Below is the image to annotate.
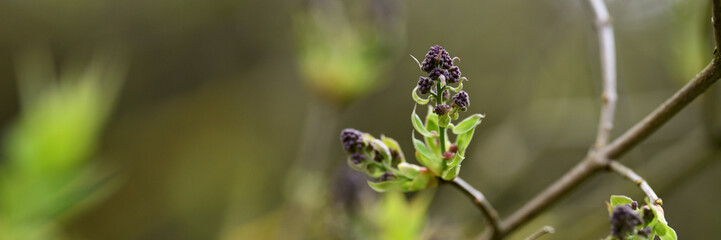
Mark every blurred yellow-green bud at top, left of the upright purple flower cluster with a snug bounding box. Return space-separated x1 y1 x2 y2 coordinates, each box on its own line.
293 0 403 104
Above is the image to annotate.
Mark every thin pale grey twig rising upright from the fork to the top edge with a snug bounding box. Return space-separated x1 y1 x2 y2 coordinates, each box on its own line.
588 0 618 150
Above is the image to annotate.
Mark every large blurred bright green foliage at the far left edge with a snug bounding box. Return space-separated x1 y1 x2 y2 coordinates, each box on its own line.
0 49 124 240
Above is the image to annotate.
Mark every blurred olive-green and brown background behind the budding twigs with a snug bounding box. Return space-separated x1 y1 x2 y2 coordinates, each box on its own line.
0 0 721 240
